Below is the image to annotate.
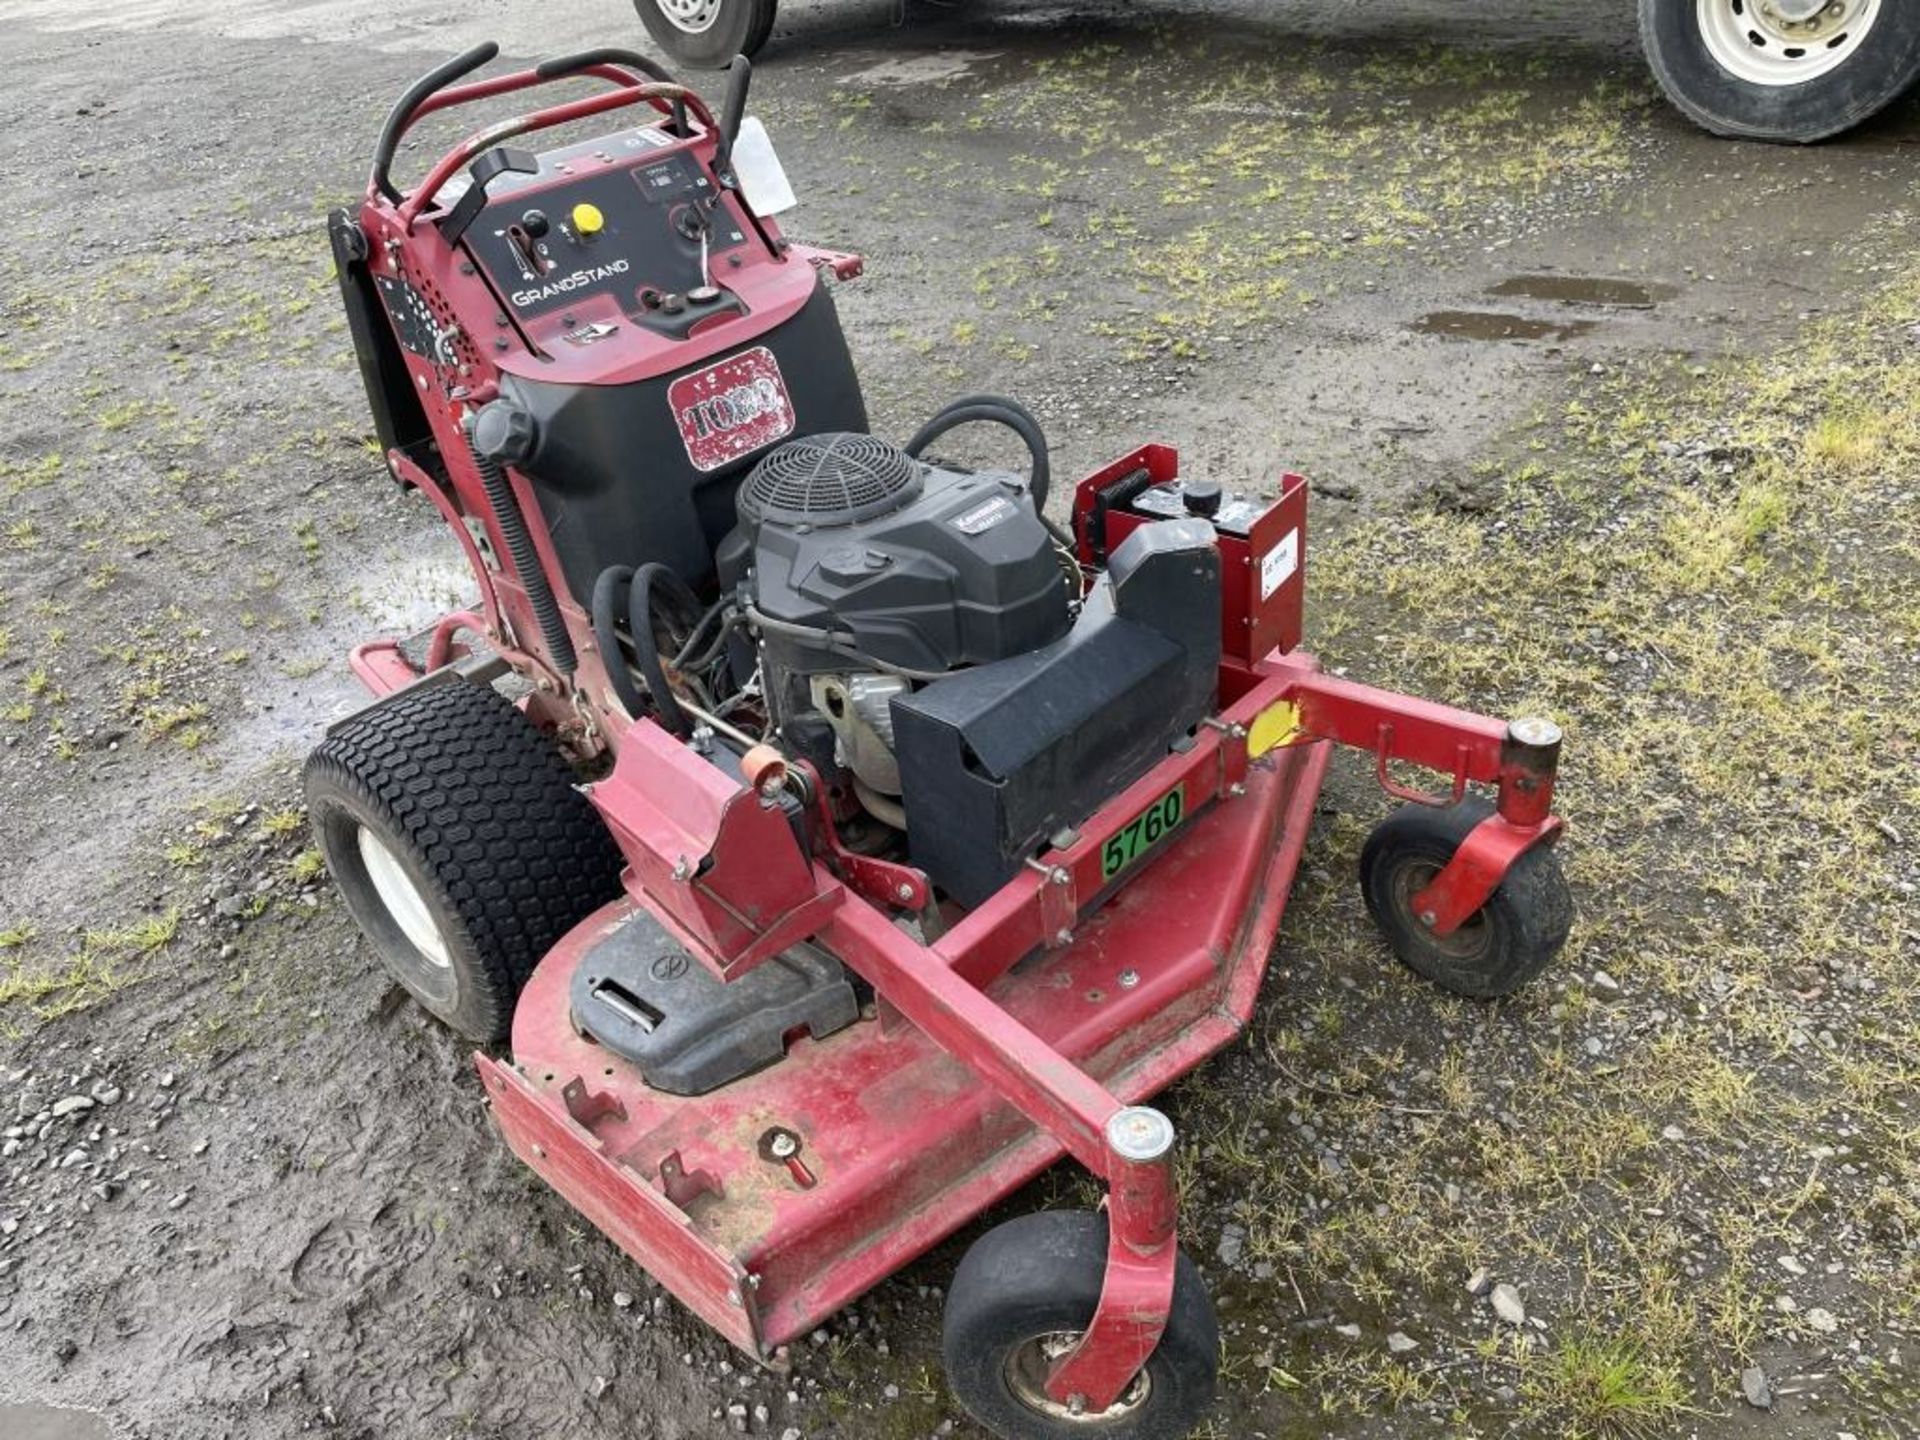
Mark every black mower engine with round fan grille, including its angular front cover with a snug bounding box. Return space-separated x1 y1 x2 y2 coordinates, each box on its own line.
716 434 1219 904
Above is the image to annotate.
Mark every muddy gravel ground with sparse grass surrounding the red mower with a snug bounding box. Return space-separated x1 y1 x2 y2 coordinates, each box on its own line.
0 0 1920 1440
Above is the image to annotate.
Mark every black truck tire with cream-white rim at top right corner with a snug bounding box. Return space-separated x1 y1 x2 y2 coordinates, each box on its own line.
1640 0 1920 144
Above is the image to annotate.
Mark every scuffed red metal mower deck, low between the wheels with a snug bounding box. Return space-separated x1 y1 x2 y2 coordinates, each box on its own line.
476 745 1331 1357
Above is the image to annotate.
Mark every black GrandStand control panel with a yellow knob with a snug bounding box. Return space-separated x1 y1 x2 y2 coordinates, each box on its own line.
442 125 747 332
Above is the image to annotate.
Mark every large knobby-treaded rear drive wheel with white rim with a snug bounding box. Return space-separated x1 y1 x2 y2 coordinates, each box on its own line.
305 680 622 1043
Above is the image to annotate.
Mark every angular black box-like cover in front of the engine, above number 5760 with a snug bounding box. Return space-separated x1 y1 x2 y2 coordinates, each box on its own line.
893 520 1219 906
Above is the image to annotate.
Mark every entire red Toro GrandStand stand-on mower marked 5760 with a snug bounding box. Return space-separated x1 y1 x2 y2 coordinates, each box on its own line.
307 46 1571 1436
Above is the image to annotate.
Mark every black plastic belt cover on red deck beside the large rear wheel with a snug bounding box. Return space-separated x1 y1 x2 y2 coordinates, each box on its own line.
570 910 860 1094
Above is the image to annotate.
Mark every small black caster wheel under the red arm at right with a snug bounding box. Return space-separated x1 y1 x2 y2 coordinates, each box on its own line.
1359 799 1572 1000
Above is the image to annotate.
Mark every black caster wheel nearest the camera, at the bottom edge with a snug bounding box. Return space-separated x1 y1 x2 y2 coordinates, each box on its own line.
941 1210 1219 1440
